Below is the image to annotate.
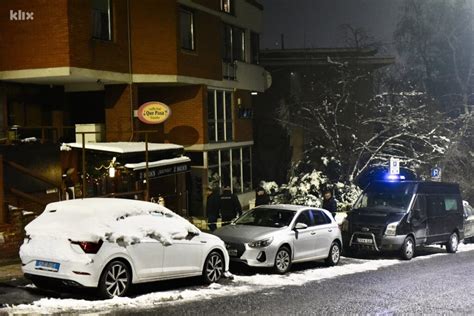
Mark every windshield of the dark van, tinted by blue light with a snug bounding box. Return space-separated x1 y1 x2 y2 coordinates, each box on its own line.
354 182 415 212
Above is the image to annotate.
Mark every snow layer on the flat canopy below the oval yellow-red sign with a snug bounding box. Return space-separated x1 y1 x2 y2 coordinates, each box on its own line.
66 142 183 154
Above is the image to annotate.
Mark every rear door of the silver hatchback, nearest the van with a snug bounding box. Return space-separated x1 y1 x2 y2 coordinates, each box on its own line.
311 210 338 257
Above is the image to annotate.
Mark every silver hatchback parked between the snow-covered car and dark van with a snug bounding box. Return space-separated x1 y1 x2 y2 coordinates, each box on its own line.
214 205 342 274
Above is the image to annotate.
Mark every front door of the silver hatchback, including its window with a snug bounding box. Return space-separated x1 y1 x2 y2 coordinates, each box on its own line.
293 210 317 261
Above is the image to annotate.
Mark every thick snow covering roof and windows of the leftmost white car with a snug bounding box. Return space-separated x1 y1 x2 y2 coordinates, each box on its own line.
25 198 200 245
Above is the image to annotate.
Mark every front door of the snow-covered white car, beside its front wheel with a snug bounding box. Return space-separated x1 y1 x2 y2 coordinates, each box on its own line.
163 235 205 277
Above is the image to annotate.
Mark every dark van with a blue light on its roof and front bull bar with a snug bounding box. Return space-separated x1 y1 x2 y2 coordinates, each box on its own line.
342 181 464 260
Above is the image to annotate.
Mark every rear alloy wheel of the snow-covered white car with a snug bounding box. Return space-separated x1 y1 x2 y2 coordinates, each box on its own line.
99 261 130 298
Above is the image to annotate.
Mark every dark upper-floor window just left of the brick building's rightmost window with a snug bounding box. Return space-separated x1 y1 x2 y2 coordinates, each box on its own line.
222 24 245 63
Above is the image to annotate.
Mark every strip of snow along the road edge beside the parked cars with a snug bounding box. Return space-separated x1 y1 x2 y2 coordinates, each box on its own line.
5 244 474 314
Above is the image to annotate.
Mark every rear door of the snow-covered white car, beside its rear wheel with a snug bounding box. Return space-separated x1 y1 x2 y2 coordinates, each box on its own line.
127 237 164 280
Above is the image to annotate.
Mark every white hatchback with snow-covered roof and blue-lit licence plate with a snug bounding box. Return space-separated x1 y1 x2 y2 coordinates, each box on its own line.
20 198 229 298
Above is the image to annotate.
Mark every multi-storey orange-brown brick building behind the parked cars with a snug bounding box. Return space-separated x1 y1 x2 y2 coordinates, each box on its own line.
0 0 271 223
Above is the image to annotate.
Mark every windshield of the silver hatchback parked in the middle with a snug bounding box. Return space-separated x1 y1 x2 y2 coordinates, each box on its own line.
235 208 296 227
